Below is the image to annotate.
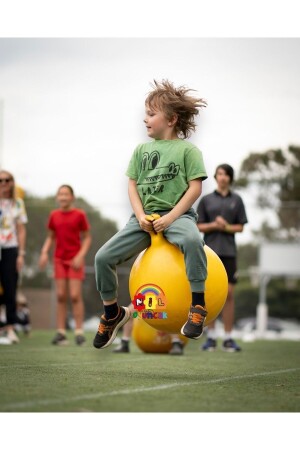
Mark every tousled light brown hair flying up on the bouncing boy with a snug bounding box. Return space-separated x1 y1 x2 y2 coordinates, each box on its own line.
145 80 207 138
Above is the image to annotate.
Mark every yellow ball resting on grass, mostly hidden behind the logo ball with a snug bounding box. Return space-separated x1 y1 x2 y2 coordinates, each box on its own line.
132 318 188 353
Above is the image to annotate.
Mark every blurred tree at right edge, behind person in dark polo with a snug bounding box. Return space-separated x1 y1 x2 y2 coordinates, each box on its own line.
235 145 300 241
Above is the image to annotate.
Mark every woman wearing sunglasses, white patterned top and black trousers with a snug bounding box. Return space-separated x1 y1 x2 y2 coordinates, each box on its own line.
0 170 28 344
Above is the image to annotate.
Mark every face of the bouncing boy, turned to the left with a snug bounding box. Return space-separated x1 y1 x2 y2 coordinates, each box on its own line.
144 105 174 139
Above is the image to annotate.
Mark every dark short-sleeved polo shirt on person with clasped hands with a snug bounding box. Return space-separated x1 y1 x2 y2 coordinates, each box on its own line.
197 191 248 257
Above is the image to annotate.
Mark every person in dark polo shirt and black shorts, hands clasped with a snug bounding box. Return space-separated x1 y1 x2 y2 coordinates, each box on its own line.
197 164 248 352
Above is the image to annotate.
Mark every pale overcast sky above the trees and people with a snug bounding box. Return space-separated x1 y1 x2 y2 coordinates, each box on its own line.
0 37 300 242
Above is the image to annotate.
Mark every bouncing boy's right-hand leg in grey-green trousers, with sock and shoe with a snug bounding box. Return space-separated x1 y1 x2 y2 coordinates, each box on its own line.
164 214 207 339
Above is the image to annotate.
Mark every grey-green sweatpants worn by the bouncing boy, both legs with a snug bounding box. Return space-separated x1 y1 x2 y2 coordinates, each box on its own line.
95 208 207 300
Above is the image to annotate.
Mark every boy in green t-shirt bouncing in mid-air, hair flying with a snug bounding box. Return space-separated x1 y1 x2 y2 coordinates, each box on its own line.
94 80 207 348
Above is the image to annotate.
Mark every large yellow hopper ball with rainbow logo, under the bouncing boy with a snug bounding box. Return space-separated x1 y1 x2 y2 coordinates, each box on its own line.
129 219 228 333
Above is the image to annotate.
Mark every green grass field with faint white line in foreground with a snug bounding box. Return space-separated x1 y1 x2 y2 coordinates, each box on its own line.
0 330 300 412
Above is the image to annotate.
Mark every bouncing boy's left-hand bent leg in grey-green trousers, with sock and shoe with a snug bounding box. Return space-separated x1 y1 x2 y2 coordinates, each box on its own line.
94 216 151 348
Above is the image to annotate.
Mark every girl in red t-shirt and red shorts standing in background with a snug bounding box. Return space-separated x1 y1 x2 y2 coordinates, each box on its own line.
39 185 91 345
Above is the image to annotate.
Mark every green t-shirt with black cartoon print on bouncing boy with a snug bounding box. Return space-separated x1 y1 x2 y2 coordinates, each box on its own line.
126 139 207 211
